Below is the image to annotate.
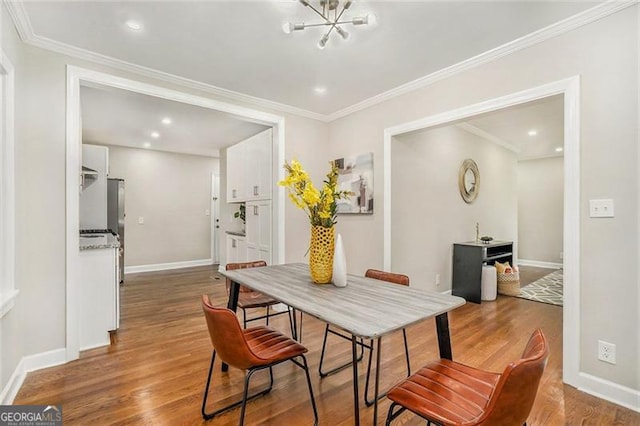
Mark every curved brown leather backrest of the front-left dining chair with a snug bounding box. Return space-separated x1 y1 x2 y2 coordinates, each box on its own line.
202 295 264 370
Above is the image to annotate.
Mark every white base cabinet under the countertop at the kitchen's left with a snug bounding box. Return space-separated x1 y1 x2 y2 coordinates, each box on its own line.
78 247 120 350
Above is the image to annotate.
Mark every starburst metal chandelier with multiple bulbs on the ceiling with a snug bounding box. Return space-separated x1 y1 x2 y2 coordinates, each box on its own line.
282 0 375 49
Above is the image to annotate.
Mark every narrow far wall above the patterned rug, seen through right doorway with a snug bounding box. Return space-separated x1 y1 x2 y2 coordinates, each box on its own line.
518 156 564 263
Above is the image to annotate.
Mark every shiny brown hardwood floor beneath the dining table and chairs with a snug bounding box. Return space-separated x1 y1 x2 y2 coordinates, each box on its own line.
14 267 640 425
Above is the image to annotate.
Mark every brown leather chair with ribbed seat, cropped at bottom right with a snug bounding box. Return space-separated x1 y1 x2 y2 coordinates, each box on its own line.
386 329 549 426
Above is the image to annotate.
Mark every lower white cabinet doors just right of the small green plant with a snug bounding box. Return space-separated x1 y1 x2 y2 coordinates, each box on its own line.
246 200 271 264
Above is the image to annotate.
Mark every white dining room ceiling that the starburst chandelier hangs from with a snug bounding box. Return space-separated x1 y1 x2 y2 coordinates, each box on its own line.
21 0 599 116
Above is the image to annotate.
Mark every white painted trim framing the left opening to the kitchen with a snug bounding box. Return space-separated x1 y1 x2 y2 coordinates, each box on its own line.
66 65 285 361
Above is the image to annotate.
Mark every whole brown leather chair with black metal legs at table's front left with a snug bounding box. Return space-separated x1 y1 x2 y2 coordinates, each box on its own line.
202 295 318 425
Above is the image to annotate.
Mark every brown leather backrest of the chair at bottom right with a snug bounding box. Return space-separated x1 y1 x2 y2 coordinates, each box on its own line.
478 329 549 425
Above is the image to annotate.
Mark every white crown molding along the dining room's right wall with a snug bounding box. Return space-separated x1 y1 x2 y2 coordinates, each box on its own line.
327 0 638 122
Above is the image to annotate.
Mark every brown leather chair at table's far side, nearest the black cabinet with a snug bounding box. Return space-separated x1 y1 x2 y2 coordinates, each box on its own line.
318 269 411 406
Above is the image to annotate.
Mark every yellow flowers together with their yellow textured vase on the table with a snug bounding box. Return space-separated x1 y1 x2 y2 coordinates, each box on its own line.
278 160 353 284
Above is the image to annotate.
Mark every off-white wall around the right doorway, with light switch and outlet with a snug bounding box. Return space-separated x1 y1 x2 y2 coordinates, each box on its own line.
328 5 640 390
